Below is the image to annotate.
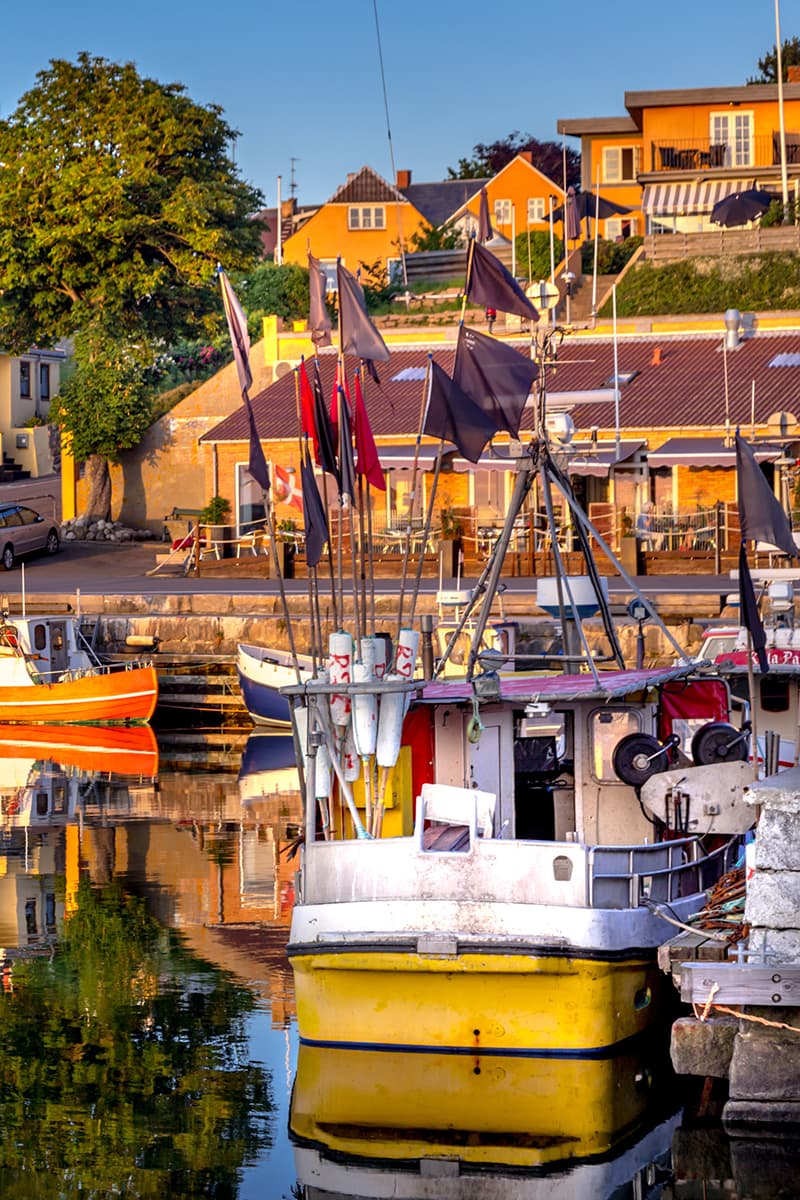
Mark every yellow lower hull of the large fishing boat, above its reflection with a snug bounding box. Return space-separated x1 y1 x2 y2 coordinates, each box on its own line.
290 944 670 1057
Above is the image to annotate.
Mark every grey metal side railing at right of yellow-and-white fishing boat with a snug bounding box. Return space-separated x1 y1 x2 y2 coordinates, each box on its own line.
588 838 740 908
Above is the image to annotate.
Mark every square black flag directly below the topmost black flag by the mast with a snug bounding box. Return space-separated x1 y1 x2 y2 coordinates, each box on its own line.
453 325 539 438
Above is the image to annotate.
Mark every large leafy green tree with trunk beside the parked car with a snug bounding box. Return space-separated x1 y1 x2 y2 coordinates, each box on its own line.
0 53 263 516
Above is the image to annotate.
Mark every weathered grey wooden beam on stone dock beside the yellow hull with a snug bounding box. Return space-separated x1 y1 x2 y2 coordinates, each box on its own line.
680 962 800 1007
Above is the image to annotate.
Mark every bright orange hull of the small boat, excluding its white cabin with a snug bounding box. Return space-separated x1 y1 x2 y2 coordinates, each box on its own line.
0 665 158 725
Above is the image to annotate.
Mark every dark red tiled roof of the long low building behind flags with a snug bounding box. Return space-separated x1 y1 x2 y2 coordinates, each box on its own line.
203 331 800 449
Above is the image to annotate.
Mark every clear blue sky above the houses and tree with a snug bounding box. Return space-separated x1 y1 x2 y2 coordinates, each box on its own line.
0 0 786 204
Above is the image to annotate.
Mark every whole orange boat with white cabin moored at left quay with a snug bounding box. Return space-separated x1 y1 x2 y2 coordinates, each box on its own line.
0 614 158 725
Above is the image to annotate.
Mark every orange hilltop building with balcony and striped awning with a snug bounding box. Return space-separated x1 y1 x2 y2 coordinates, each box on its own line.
557 68 800 238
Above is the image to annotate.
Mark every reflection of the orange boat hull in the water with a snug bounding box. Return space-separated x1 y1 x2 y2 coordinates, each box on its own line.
0 725 158 778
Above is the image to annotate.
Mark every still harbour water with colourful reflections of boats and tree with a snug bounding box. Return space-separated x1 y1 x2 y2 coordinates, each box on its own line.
0 730 796 1200
